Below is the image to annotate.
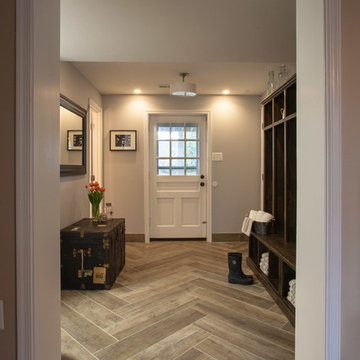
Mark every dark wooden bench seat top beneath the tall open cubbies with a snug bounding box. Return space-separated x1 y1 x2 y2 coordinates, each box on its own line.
251 233 296 271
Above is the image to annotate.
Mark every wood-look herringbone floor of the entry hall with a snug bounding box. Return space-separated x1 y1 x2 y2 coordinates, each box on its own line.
61 241 295 360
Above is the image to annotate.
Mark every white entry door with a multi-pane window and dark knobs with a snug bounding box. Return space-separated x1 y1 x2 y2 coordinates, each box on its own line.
149 115 207 238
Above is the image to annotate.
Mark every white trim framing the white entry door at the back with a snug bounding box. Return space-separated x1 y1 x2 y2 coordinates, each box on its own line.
144 110 212 243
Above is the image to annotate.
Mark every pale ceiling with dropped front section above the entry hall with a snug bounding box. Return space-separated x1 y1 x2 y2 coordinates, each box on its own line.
61 0 296 94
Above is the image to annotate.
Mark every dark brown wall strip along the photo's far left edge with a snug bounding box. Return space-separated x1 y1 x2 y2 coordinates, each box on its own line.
0 0 16 360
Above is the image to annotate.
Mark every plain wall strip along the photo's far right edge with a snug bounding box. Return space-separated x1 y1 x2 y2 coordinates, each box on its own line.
341 0 360 360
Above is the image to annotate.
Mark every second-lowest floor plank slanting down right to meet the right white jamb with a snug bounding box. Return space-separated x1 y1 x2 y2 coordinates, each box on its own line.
194 301 295 351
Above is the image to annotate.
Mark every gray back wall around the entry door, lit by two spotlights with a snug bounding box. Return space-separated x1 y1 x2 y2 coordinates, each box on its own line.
103 95 260 234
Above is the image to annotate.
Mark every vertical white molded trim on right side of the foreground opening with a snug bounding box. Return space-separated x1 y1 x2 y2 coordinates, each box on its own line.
325 0 342 360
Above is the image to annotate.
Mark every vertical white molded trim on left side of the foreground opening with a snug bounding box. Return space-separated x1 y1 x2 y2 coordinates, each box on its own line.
15 0 35 360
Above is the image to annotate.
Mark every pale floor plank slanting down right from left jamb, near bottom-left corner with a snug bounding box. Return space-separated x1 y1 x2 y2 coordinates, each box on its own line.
61 304 117 353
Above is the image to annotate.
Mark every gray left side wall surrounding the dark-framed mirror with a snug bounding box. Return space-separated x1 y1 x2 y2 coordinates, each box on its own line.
60 62 102 228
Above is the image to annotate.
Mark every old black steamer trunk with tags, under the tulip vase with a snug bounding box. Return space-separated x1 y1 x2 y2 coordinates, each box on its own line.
60 219 125 290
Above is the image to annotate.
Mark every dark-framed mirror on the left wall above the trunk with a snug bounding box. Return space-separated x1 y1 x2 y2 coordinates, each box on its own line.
60 94 86 176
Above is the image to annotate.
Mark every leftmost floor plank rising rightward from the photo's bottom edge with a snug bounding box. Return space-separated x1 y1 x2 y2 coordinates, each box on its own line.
95 309 204 360
